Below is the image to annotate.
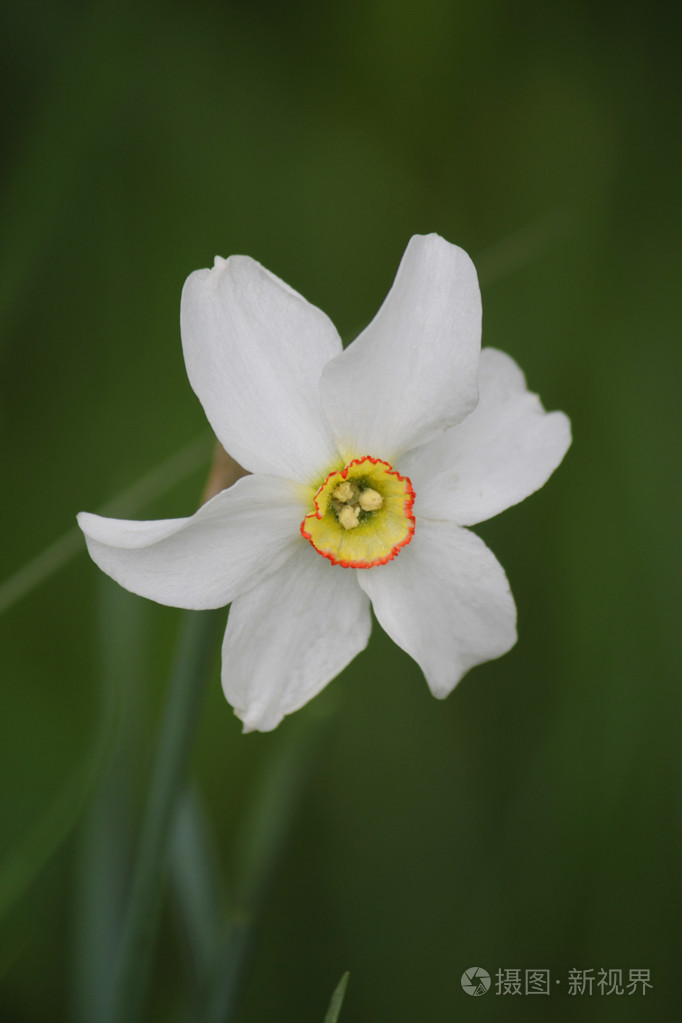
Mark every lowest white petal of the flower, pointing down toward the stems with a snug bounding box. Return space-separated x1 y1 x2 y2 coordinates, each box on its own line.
223 544 371 731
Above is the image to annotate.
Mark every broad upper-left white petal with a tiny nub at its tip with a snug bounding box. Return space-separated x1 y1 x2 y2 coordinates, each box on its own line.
180 256 342 484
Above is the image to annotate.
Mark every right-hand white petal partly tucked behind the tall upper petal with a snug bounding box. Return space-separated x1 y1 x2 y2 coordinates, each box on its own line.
399 348 571 526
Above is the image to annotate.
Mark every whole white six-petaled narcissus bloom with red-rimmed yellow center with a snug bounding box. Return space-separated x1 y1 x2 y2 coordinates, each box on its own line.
79 234 571 731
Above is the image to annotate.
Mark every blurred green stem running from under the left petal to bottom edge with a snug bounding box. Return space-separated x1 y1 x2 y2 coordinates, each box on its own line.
108 611 224 1023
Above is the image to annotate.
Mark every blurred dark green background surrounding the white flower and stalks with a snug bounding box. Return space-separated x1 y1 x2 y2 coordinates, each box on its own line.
0 0 682 1023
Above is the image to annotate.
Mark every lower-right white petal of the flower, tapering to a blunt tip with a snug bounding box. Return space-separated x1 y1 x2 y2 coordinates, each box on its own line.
358 519 516 699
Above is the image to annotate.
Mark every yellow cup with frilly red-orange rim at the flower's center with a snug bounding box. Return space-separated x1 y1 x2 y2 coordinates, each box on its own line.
301 455 414 569
